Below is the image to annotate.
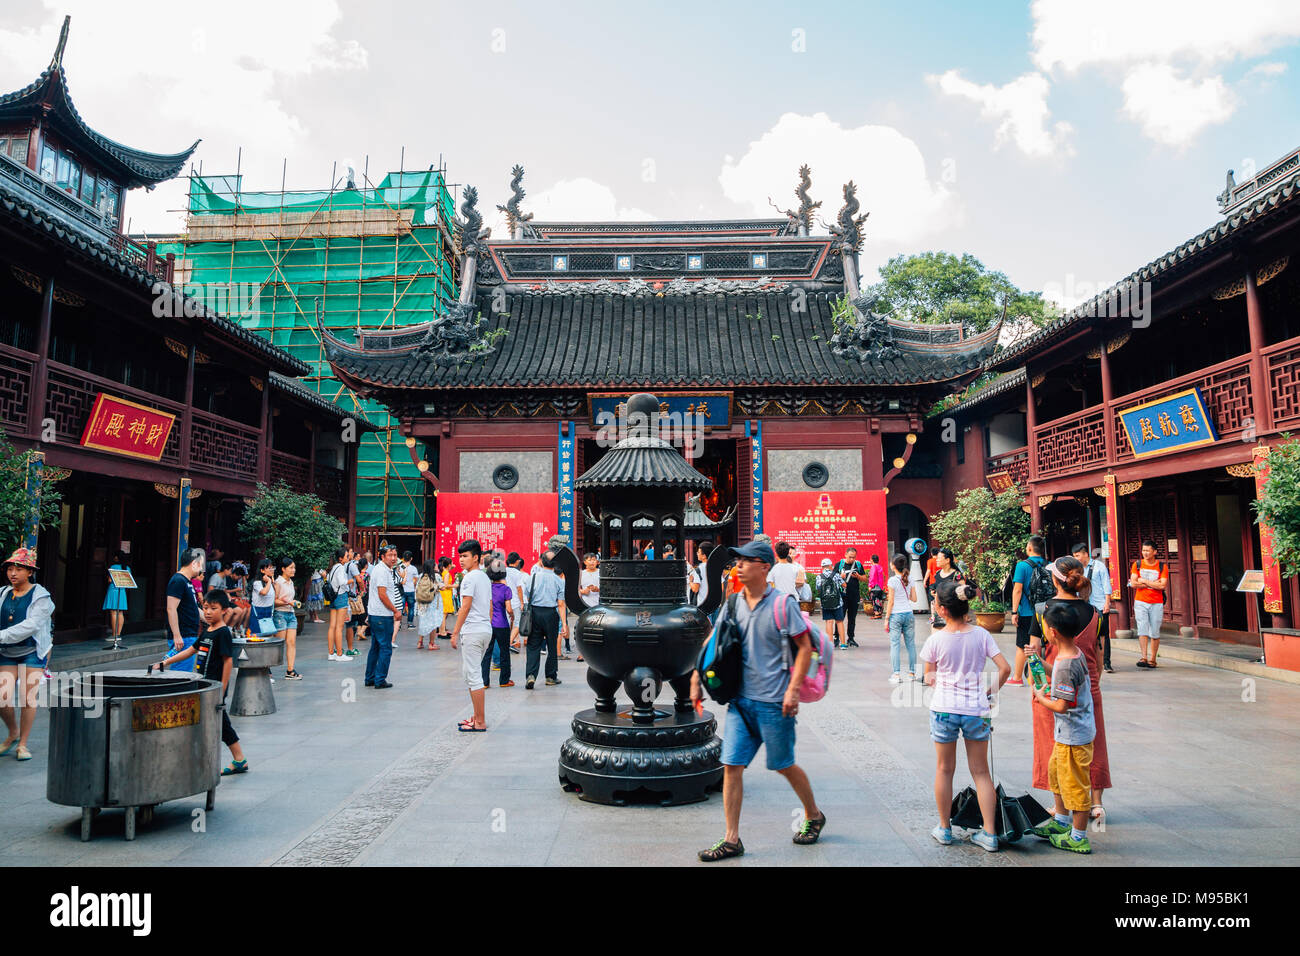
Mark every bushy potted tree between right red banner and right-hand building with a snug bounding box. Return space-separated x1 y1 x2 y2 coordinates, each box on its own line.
930 485 1030 611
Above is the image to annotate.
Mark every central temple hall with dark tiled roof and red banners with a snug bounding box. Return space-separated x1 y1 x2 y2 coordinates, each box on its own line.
321 168 998 558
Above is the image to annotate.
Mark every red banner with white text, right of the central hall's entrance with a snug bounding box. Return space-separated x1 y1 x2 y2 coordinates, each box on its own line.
763 490 889 571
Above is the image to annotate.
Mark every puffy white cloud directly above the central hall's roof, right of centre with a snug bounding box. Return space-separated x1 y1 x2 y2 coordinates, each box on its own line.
718 113 961 274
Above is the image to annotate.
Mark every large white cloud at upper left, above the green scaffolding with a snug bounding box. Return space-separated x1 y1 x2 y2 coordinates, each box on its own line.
0 0 368 232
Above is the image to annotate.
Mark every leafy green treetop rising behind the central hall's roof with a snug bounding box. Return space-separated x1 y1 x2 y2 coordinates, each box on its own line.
871 252 1061 332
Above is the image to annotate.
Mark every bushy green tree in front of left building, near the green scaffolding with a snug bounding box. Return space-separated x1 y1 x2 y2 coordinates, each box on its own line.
239 481 345 593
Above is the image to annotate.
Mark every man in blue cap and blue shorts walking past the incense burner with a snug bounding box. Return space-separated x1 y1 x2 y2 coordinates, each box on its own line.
690 541 826 862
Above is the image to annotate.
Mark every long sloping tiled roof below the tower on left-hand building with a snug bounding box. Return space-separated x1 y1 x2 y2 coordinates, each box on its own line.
0 179 312 375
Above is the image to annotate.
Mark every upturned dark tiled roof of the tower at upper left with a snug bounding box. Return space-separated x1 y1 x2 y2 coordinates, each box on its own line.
0 65 200 189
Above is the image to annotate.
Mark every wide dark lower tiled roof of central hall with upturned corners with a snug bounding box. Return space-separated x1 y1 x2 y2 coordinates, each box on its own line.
322 293 992 389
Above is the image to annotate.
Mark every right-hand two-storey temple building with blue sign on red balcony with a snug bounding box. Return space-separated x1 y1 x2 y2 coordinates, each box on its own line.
930 151 1300 669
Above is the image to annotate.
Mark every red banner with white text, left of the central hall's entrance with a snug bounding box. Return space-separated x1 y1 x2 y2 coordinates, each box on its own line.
437 492 560 568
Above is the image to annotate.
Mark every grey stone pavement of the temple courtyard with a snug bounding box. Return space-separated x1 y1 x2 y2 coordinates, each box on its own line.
0 618 1300 866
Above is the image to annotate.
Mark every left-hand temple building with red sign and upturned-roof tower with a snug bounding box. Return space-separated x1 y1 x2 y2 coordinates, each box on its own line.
0 21 373 640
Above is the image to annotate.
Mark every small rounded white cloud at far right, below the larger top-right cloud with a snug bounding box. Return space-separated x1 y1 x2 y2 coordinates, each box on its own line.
1123 64 1236 147
